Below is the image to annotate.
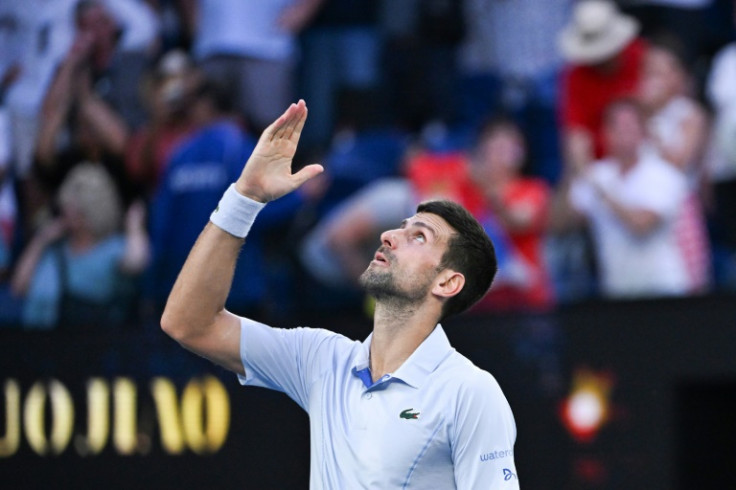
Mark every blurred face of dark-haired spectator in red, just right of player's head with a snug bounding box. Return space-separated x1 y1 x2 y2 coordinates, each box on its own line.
476 126 526 179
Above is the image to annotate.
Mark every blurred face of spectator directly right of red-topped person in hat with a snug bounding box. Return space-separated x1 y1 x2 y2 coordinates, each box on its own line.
639 46 685 108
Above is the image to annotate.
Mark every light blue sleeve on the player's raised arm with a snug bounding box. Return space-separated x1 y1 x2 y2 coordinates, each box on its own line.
238 318 344 410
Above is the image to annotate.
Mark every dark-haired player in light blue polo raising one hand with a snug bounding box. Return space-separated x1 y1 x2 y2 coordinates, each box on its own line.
161 100 519 489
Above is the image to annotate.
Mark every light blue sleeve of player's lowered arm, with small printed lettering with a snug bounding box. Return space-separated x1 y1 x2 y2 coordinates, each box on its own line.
452 371 519 490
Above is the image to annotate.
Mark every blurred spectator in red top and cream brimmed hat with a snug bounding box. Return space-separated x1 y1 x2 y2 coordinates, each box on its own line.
558 0 645 174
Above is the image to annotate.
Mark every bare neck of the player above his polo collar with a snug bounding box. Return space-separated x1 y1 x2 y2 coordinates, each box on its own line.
370 301 439 381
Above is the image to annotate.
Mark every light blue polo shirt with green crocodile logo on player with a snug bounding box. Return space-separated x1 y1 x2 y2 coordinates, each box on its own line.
240 319 519 490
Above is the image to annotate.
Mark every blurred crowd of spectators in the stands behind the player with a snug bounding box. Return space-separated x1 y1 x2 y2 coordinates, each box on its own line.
0 0 736 329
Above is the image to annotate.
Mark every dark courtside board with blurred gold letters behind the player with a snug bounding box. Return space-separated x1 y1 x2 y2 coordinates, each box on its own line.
0 298 736 490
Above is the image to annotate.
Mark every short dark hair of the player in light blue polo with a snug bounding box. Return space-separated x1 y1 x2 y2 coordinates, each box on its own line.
417 200 498 320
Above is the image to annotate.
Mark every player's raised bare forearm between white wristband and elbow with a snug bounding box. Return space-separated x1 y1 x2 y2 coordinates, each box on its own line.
161 223 243 341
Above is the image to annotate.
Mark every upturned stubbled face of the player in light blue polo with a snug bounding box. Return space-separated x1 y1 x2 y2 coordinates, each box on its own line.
360 213 454 303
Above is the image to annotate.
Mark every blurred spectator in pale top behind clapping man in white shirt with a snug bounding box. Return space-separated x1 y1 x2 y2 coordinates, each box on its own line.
639 37 711 292
